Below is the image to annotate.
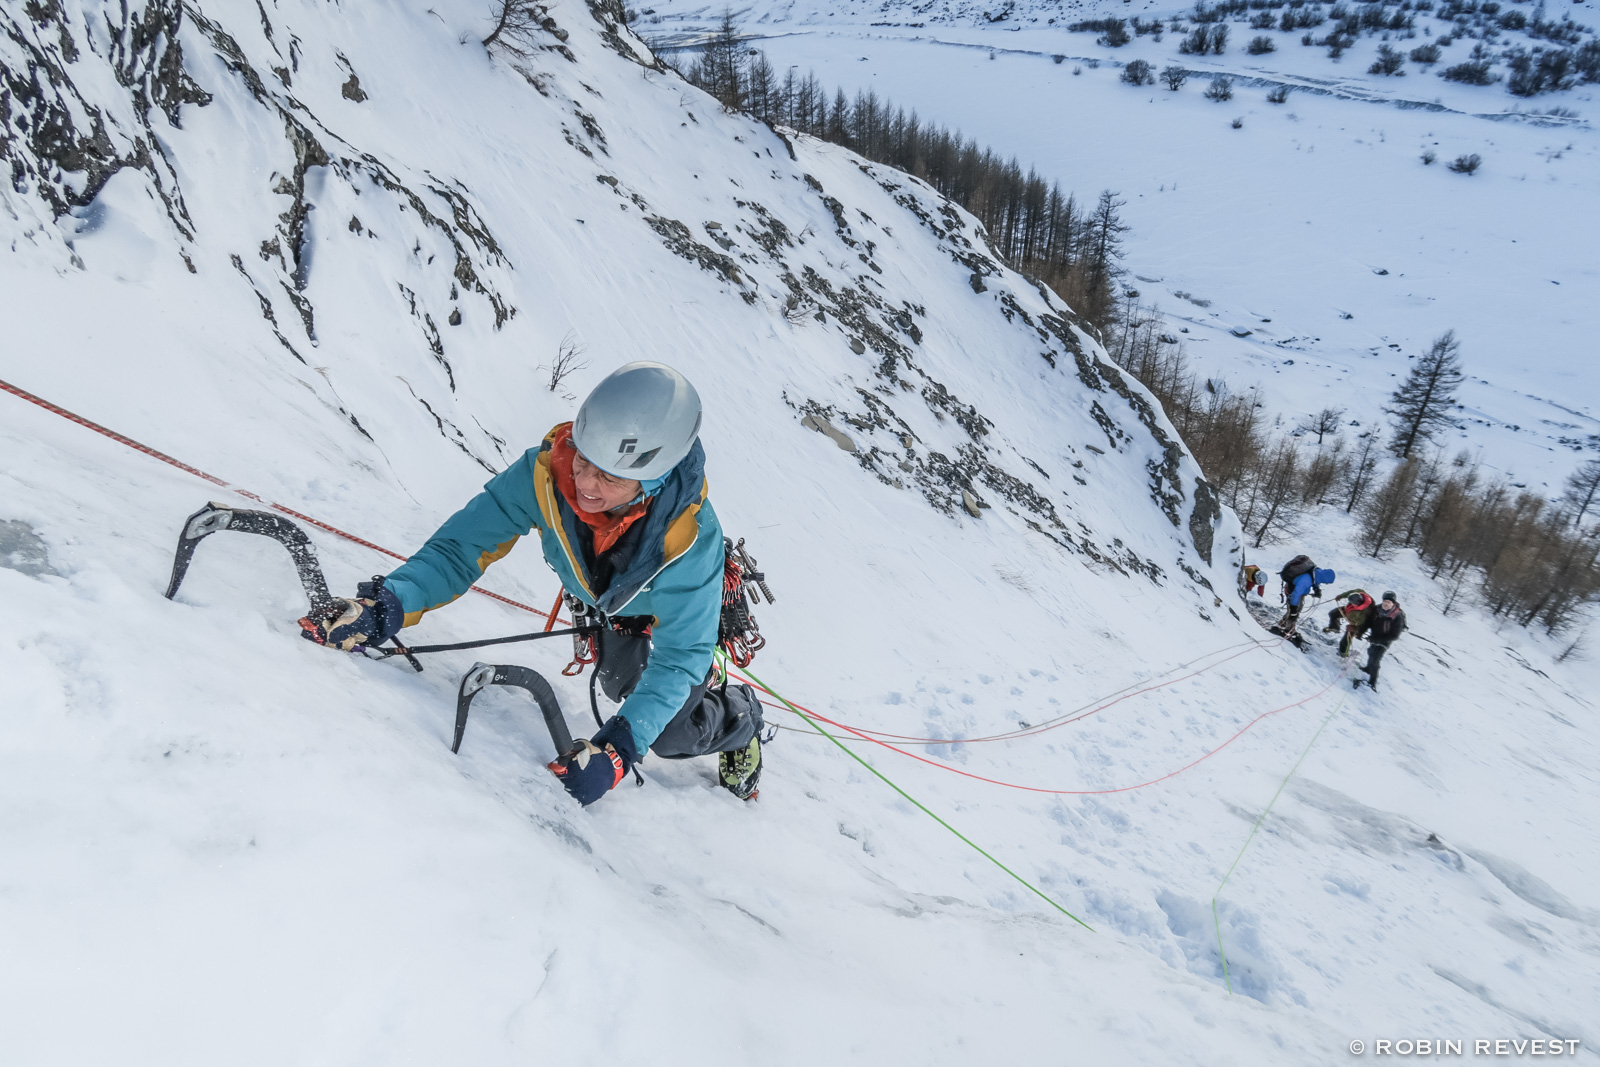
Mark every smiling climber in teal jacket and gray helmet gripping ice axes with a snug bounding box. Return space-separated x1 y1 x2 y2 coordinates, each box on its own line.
306 363 762 805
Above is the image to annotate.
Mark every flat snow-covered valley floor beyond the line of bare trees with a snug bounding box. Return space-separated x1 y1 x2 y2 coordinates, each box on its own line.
638 2 1600 496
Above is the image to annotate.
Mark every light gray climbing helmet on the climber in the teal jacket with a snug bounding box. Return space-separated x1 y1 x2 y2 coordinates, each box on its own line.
573 362 701 482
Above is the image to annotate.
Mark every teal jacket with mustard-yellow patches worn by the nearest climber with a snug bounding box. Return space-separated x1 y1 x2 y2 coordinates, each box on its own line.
386 424 723 753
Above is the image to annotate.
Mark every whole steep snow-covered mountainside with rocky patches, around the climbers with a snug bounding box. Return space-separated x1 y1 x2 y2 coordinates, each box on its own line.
0 0 1600 1064
